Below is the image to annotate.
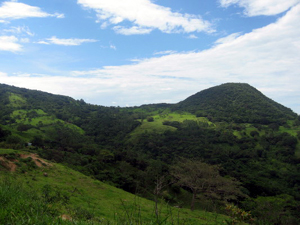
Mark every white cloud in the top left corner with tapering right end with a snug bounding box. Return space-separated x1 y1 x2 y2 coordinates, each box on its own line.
0 1 64 21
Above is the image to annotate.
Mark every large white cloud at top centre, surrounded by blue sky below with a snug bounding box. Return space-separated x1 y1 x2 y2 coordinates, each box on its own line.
77 0 213 35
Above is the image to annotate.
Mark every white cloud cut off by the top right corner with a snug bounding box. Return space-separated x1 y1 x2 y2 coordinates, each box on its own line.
220 0 300 16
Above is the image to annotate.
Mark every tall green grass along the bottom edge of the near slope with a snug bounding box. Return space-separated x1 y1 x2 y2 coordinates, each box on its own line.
0 174 225 225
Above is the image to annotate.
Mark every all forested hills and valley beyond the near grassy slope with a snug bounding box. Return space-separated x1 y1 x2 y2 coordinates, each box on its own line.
0 83 300 224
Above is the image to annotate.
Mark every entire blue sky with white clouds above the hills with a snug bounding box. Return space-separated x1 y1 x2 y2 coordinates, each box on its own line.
0 0 300 114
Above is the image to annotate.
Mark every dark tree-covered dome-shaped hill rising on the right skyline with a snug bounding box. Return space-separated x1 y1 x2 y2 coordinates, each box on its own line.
174 83 296 124
